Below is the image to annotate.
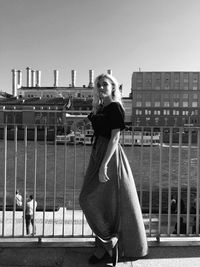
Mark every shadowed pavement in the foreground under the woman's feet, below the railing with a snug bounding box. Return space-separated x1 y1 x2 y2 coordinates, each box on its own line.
0 244 200 267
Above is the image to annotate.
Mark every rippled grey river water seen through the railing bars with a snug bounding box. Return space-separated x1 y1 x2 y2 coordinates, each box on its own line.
0 140 197 213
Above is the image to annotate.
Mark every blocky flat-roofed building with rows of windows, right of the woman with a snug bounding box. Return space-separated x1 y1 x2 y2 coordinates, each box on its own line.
131 71 200 127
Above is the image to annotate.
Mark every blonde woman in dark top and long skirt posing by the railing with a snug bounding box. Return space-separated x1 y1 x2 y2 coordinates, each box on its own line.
79 74 148 266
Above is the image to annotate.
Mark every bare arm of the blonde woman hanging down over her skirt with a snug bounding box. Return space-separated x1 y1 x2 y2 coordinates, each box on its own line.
99 129 120 183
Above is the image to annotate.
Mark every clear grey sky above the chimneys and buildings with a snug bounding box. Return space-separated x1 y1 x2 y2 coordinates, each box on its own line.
0 0 200 96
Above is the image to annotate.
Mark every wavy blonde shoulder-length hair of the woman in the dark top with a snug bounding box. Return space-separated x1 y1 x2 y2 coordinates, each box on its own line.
92 73 124 114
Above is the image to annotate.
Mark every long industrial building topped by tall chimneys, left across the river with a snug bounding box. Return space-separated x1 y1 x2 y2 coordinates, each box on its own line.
0 67 132 139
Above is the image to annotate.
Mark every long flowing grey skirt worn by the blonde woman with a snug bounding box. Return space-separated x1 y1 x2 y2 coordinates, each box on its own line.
79 136 148 257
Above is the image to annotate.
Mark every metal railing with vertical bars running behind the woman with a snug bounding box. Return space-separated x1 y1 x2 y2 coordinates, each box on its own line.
0 111 200 242
